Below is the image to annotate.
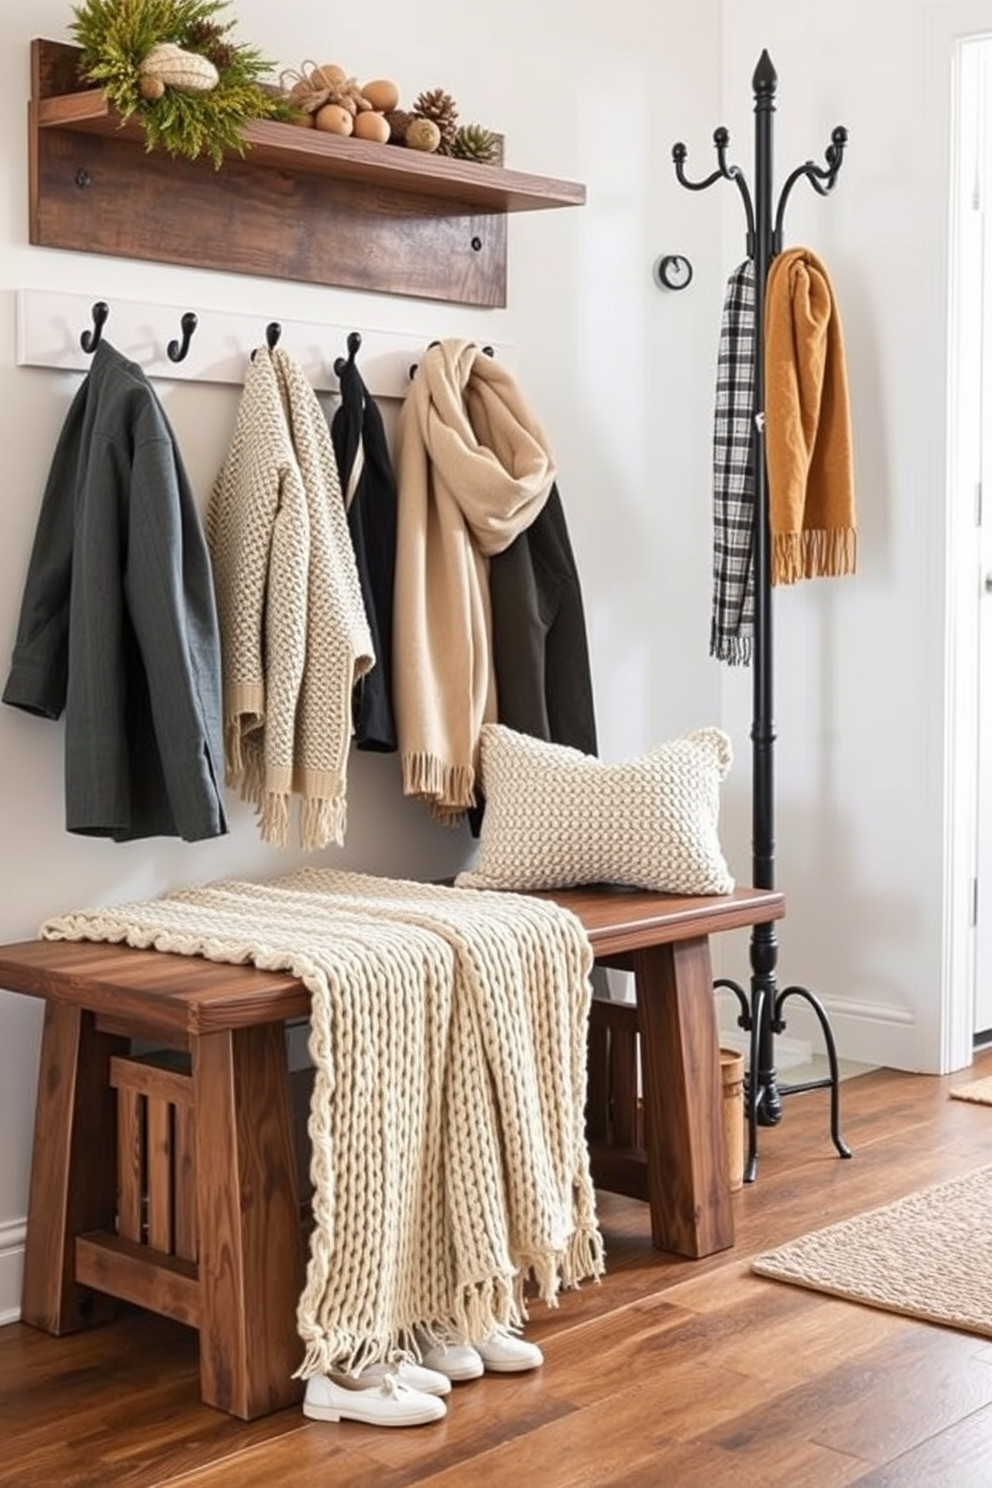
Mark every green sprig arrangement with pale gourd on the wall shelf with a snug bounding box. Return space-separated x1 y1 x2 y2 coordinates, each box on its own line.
70 0 290 168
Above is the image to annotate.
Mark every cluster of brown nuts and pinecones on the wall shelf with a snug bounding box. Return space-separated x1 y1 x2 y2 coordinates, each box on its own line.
281 62 501 162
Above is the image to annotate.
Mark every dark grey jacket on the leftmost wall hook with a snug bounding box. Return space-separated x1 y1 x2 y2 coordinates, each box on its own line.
3 341 228 842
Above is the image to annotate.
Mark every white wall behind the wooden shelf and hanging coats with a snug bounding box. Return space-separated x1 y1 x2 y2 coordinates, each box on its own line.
0 0 728 1318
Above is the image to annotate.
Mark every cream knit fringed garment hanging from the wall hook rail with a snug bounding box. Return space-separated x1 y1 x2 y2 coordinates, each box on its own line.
207 347 375 850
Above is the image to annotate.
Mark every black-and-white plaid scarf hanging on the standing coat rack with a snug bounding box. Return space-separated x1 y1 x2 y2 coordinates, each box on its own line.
709 259 754 667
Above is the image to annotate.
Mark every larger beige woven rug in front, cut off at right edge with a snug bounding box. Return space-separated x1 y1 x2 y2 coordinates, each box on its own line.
751 1167 992 1336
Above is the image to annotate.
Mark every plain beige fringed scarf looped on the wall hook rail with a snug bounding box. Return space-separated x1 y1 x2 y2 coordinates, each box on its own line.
393 341 556 824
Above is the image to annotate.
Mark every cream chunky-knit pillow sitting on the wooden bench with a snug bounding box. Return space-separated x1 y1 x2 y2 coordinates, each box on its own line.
455 723 733 894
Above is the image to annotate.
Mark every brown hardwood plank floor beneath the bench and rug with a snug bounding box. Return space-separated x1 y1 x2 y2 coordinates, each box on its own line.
0 1054 992 1488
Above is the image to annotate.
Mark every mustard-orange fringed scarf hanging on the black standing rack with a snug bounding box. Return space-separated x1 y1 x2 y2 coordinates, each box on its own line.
764 248 857 583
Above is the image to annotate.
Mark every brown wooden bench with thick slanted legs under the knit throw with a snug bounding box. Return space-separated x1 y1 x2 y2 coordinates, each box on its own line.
0 888 784 1420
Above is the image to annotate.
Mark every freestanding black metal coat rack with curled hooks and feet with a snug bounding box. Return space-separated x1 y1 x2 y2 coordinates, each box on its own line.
672 51 851 1183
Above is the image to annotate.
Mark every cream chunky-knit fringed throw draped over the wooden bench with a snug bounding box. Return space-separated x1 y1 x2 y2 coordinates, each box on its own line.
42 869 602 1376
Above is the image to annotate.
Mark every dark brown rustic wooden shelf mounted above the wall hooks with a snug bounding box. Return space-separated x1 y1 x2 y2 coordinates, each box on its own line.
28 40 586 307
